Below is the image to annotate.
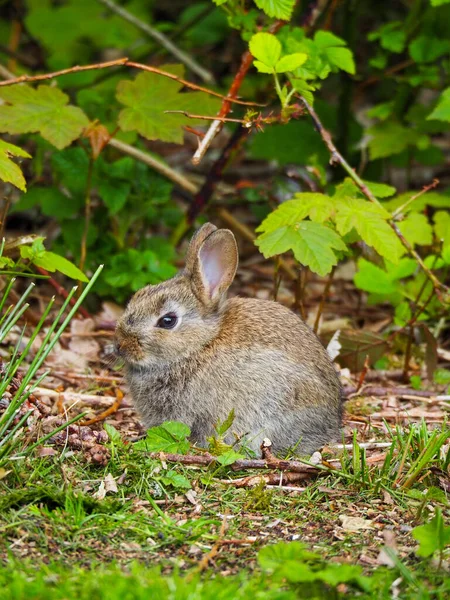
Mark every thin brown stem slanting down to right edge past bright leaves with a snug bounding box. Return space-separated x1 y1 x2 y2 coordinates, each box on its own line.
300 96 449 297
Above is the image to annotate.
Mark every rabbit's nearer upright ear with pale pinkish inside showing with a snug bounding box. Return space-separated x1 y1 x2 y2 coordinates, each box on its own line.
192 229 238 304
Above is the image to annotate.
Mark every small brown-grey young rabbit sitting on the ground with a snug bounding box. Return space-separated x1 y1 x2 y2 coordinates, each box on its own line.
115 223 343 455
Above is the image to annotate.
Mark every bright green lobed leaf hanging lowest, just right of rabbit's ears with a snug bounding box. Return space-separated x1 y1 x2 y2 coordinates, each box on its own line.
255 221 347 276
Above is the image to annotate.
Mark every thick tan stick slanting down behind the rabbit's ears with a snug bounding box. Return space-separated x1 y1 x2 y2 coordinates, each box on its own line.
109 139 297 280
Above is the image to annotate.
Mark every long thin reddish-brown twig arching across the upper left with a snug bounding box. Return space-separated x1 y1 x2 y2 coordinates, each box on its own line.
0 58 263 106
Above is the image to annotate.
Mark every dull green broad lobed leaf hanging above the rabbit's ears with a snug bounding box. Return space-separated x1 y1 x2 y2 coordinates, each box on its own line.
116 65 221 144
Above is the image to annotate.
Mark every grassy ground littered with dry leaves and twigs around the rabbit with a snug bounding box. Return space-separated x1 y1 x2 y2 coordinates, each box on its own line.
0 265 450 598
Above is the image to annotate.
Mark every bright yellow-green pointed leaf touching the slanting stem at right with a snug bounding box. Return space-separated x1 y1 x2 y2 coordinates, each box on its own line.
336 198 405 263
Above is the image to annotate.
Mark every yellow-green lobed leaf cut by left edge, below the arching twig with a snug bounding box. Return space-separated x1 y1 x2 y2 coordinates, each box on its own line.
0 85 89 150
